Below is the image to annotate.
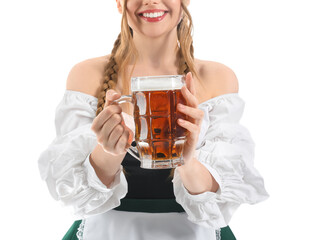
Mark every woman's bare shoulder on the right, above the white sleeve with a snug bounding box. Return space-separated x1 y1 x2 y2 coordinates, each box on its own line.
195 59 239 97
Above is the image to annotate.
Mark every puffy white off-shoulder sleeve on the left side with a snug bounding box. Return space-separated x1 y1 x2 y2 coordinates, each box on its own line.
38 90 127 218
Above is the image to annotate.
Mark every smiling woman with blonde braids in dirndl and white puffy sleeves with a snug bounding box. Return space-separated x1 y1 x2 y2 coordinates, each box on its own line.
39 0 268 240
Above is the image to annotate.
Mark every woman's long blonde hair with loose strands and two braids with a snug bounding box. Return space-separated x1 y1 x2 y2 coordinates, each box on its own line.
96 0 203 178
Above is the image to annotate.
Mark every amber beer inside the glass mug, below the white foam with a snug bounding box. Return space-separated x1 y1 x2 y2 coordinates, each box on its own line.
133 85 187 167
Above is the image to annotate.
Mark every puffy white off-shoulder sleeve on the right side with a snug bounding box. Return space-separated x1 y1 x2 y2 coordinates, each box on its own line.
173 93 269 229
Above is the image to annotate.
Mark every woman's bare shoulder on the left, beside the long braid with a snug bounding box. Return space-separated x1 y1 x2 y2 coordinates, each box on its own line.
66 55 109 97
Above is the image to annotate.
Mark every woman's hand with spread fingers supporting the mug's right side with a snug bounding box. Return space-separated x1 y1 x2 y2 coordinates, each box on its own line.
177 72 204 165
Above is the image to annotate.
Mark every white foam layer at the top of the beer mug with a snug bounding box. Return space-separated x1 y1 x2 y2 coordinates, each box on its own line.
131 75 185 92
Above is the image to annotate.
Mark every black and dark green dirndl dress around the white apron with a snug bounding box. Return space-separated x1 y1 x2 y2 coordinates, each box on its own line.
63 153 236 240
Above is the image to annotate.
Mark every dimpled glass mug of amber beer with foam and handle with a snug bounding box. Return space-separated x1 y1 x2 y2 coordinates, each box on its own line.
115 75 187 169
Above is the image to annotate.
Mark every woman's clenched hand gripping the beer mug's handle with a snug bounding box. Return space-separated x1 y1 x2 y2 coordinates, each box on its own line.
91 89 133 156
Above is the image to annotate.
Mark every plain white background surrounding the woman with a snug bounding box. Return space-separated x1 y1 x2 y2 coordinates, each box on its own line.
0 0 311 240
